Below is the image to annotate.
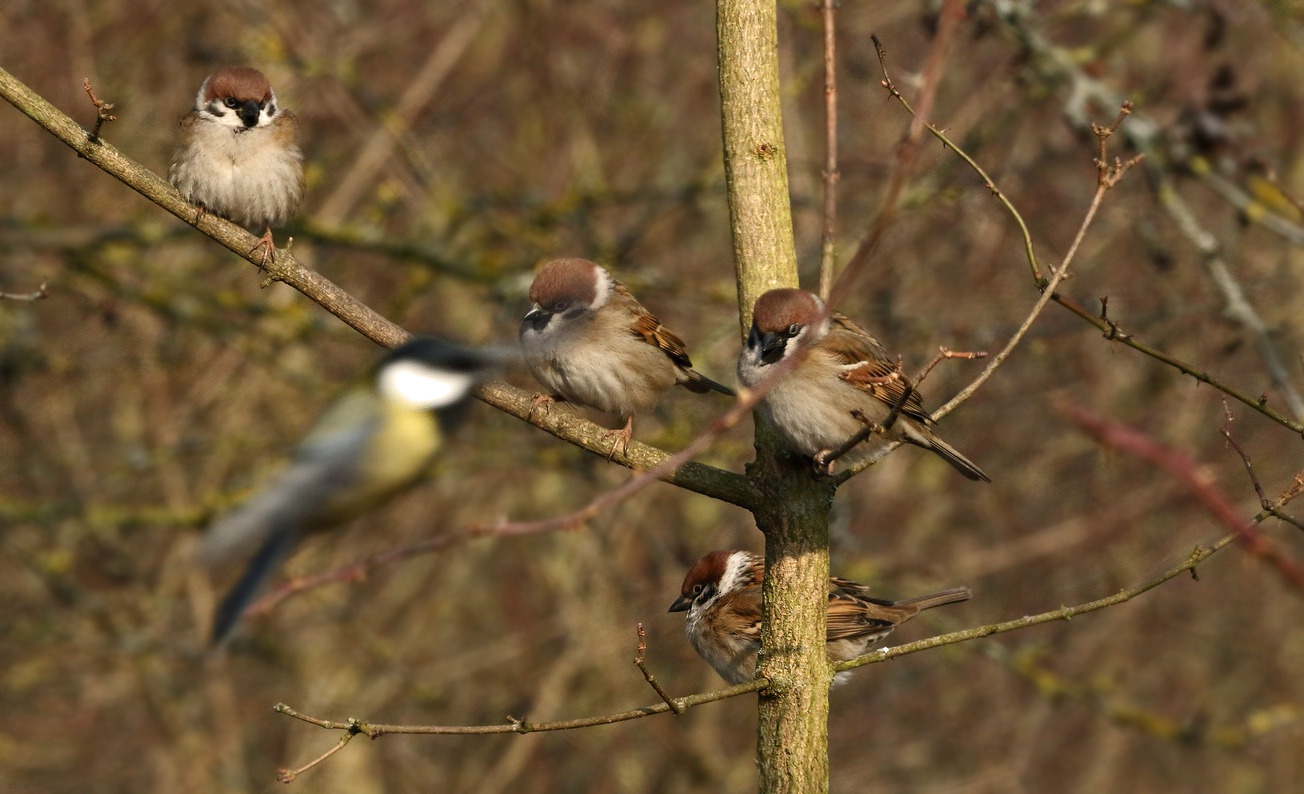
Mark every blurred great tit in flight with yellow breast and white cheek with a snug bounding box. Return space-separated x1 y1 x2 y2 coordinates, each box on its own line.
198 338 494 644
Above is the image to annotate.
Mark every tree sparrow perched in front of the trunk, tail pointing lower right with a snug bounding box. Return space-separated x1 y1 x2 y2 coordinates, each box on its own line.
738 289 991 482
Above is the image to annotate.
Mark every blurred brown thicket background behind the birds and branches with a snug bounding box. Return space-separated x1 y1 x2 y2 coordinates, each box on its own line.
0 0 1304 794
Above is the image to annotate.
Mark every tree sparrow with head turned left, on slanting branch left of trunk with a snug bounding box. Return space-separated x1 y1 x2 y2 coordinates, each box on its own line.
520 259 734 455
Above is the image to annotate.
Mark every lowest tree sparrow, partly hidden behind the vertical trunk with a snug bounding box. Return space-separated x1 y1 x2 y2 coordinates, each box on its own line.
670 551 971 683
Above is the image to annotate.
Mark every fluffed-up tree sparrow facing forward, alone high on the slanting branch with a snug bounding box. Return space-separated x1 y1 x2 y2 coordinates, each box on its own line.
168 66 304 265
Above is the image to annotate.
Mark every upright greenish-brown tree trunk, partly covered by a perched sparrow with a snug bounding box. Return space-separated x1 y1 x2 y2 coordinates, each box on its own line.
716 0 833 794
